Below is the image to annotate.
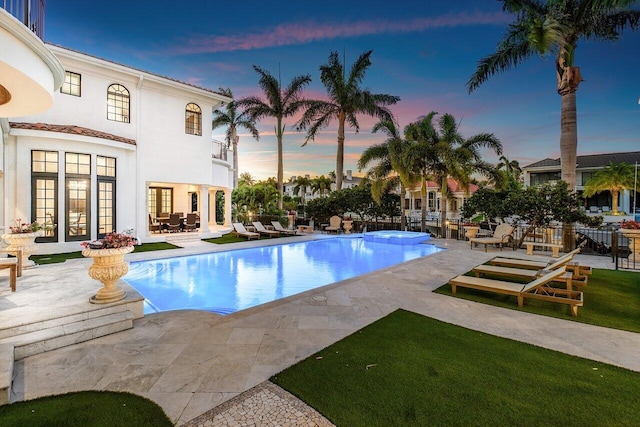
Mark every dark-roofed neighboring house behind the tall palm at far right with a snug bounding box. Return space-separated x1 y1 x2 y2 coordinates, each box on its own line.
522 151 640 214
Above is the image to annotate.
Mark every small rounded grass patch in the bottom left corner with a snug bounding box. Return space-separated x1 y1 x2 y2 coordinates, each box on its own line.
0 391 173 427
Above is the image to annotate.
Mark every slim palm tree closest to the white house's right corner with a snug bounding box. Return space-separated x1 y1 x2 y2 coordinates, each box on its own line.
212 88 260 188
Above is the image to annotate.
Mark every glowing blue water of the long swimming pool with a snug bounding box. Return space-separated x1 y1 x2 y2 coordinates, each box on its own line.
124 238 442 314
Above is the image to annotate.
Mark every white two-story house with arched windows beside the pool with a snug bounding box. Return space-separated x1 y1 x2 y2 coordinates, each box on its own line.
1 40 233 253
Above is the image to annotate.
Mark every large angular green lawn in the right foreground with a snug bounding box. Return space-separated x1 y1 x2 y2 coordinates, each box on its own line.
271 310 640 426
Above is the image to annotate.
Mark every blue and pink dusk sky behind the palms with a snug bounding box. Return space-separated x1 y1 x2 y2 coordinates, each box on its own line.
45 0 640 179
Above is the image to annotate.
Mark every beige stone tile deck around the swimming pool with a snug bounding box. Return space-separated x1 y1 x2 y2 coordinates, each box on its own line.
0 235 640 426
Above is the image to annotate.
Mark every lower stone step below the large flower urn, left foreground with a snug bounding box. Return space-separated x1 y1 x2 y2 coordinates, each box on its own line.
0 310 135 362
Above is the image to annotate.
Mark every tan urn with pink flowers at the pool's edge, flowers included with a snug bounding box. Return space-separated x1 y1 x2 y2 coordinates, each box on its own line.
81 232 137 304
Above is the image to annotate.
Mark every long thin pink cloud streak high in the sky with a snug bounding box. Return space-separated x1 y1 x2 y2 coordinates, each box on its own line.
175 12 509 55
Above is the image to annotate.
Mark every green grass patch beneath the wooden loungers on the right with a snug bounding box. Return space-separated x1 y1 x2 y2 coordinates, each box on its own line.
434 269 640 332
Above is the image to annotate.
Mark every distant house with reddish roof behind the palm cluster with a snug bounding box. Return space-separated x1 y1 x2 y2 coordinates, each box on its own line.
404 178 479 219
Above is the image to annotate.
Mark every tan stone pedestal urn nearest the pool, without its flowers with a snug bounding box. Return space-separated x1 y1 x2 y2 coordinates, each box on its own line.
82 246 133 304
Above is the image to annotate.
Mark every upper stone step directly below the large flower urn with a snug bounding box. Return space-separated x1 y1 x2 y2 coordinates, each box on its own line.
0 298 144 342
